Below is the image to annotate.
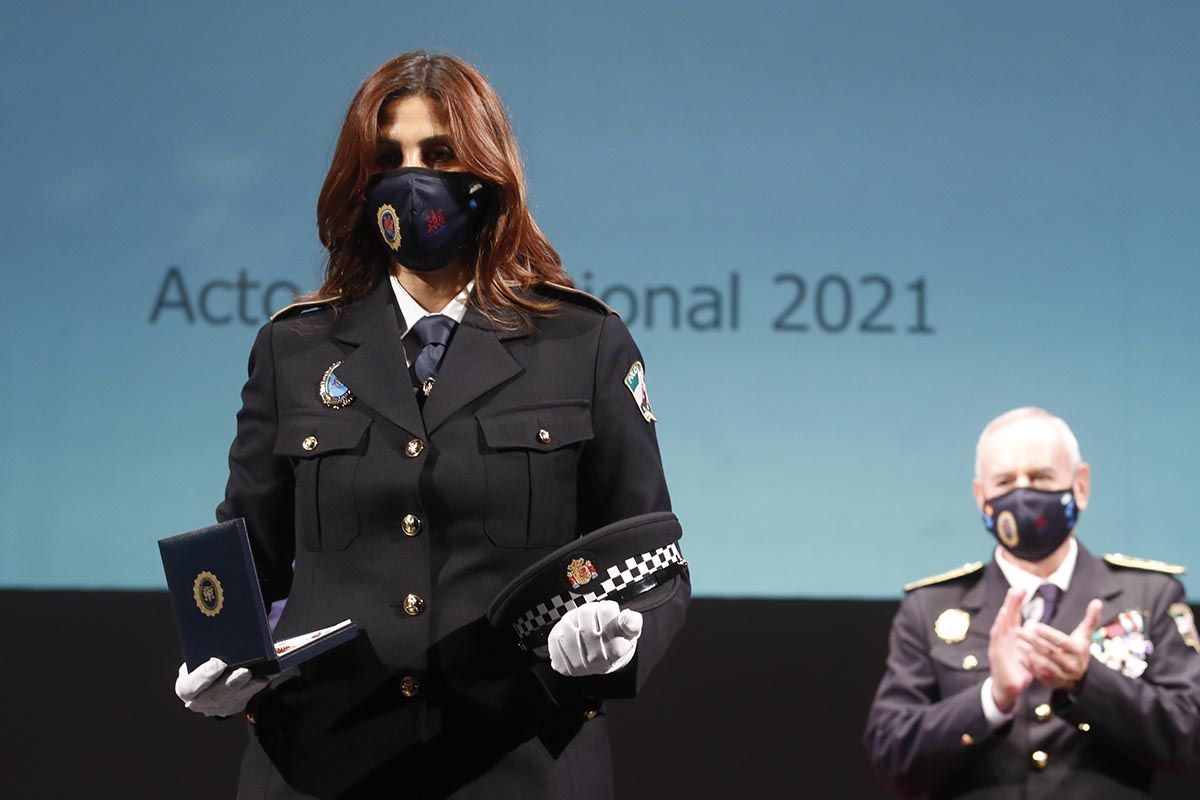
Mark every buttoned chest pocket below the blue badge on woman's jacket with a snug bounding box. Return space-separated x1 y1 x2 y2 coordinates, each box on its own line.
275 411 371 552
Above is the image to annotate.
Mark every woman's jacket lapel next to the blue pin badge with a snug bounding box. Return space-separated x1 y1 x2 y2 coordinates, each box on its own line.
335 279 425 435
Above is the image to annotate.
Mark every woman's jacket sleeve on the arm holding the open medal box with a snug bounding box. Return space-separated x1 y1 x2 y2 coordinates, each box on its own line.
217 323 295 604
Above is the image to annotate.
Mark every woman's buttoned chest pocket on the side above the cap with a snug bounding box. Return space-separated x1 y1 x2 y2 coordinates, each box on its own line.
479 401 593 547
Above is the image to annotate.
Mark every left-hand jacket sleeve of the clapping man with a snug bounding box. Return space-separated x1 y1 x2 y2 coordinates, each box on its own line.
864 595 992 795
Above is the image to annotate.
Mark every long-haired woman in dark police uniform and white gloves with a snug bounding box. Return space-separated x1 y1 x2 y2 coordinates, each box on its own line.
176 53 690 799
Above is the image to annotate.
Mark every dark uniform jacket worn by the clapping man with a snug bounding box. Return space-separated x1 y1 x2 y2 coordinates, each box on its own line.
865 546 1200 800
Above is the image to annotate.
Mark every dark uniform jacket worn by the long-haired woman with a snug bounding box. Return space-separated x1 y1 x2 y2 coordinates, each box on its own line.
217 281 690 799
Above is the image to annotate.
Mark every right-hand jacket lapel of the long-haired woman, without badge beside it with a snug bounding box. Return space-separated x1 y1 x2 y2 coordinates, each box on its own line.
425 306 527 433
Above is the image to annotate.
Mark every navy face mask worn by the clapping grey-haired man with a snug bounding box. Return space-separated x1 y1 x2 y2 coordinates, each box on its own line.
983 488 1079 561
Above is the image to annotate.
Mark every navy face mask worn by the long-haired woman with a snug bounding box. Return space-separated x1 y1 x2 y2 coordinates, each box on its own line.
366 167 486 272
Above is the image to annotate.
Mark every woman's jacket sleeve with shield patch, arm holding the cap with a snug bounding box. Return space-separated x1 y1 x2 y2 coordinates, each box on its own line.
535 314 691 706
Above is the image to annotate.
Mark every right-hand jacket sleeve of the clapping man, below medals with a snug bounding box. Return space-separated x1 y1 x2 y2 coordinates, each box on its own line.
1051 579 1200 769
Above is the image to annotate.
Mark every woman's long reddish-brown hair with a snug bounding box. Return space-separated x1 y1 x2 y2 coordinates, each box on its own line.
317 52 571 320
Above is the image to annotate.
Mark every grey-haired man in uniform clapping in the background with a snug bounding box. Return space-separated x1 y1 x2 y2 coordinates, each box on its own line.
865 408 1200 799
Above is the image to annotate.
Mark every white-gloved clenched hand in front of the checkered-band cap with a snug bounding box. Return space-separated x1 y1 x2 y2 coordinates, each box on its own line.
546 600 642 678
